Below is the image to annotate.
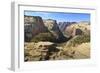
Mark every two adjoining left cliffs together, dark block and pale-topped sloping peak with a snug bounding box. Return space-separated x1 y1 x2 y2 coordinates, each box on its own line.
24 16 66 42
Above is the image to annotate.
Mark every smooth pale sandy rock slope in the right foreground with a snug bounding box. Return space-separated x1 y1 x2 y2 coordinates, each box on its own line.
63 42 90 59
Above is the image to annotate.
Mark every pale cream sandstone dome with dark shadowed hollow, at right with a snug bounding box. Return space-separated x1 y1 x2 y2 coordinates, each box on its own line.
63 22 90 37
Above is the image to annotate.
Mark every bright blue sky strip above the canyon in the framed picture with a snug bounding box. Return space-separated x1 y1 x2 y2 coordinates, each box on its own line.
24 11 90 22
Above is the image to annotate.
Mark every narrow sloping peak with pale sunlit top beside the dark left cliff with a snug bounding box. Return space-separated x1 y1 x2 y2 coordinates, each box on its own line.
43 19 66 42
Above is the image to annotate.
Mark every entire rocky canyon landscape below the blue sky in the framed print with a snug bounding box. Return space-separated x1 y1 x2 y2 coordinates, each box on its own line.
24 16 90 62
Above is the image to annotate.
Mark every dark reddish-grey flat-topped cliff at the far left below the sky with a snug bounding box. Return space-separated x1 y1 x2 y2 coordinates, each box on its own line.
24 16 47 41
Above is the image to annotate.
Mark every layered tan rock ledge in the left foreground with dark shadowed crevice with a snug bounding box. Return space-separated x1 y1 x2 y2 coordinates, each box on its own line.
24 42 60 61
